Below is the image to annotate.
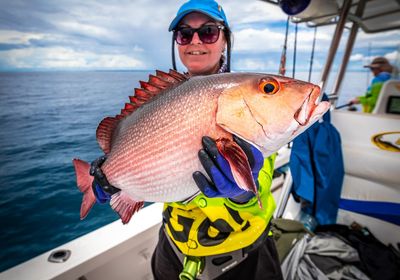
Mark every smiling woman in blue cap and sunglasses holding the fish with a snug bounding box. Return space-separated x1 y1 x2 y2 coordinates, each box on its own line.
152 0 282 279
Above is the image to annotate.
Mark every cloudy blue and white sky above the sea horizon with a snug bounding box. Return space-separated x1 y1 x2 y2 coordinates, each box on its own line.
0 0 400 73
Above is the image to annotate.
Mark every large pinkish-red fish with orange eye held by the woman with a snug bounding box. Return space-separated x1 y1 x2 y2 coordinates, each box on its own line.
73 70 329 223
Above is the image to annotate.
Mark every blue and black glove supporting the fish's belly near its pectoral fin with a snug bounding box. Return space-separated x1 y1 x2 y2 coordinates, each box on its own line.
193 136 264 204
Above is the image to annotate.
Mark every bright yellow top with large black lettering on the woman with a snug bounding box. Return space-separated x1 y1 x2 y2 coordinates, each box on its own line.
163 154 276 257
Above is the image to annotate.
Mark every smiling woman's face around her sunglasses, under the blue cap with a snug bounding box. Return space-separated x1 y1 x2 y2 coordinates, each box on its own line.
178 12 226 75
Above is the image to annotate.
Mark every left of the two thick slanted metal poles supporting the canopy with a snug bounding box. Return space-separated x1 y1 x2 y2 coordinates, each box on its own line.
320 0 352 92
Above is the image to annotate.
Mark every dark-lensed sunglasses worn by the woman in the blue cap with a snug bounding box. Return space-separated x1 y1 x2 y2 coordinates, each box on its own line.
175 25 225 46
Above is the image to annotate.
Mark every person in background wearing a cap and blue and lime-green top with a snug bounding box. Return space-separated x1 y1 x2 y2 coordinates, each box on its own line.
350 57 393 113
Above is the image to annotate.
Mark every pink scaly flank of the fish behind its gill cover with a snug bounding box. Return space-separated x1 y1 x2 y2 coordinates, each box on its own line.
102 75 225 201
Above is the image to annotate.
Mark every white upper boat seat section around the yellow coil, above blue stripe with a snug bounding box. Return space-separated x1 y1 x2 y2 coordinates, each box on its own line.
332 111 400 187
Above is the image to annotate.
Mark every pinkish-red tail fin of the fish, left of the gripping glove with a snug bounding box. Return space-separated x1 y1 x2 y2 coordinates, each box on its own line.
72 159 96 220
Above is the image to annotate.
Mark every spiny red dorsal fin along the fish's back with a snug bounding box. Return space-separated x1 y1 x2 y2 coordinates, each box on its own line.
96 69 189 154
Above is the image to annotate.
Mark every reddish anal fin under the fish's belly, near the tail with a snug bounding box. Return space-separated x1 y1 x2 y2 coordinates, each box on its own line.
110 191 144 224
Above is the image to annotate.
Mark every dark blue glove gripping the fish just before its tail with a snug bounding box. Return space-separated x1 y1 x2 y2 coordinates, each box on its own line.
89 155 118 204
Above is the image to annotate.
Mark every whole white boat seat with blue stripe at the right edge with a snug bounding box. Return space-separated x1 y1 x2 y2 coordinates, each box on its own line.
332 110 400 244
